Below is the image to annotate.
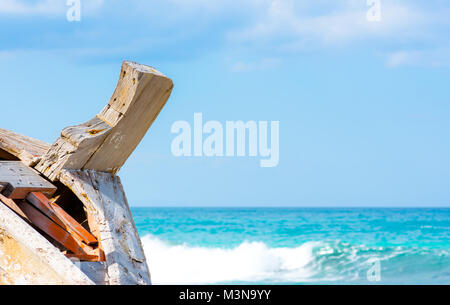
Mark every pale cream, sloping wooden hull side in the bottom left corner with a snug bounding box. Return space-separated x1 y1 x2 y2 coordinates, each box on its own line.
0 204 94 285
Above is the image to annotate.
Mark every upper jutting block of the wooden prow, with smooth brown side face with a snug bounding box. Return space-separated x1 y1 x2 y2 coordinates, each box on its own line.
89 62 173 173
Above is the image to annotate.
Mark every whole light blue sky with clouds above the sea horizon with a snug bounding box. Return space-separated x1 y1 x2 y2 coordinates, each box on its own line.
0 0 450 207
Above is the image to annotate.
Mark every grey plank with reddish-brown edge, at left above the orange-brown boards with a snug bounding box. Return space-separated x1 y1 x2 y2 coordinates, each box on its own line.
0 161 56 199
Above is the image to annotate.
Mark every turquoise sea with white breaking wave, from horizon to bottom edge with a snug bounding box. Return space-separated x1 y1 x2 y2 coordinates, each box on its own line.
132 208 450 284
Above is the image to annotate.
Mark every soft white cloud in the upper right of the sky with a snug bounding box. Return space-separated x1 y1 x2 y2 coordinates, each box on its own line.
229 0 424 46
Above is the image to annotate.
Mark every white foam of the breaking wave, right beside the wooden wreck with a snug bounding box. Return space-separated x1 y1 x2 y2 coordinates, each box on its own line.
142 235 326 284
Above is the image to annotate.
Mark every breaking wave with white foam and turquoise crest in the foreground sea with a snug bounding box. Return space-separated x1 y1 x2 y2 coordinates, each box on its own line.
142 235 450 284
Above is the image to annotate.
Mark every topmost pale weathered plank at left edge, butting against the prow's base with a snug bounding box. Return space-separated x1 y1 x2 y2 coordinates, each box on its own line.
0 128 50 166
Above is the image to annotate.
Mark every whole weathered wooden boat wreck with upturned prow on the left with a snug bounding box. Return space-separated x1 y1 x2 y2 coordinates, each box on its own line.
0 61 173 285
